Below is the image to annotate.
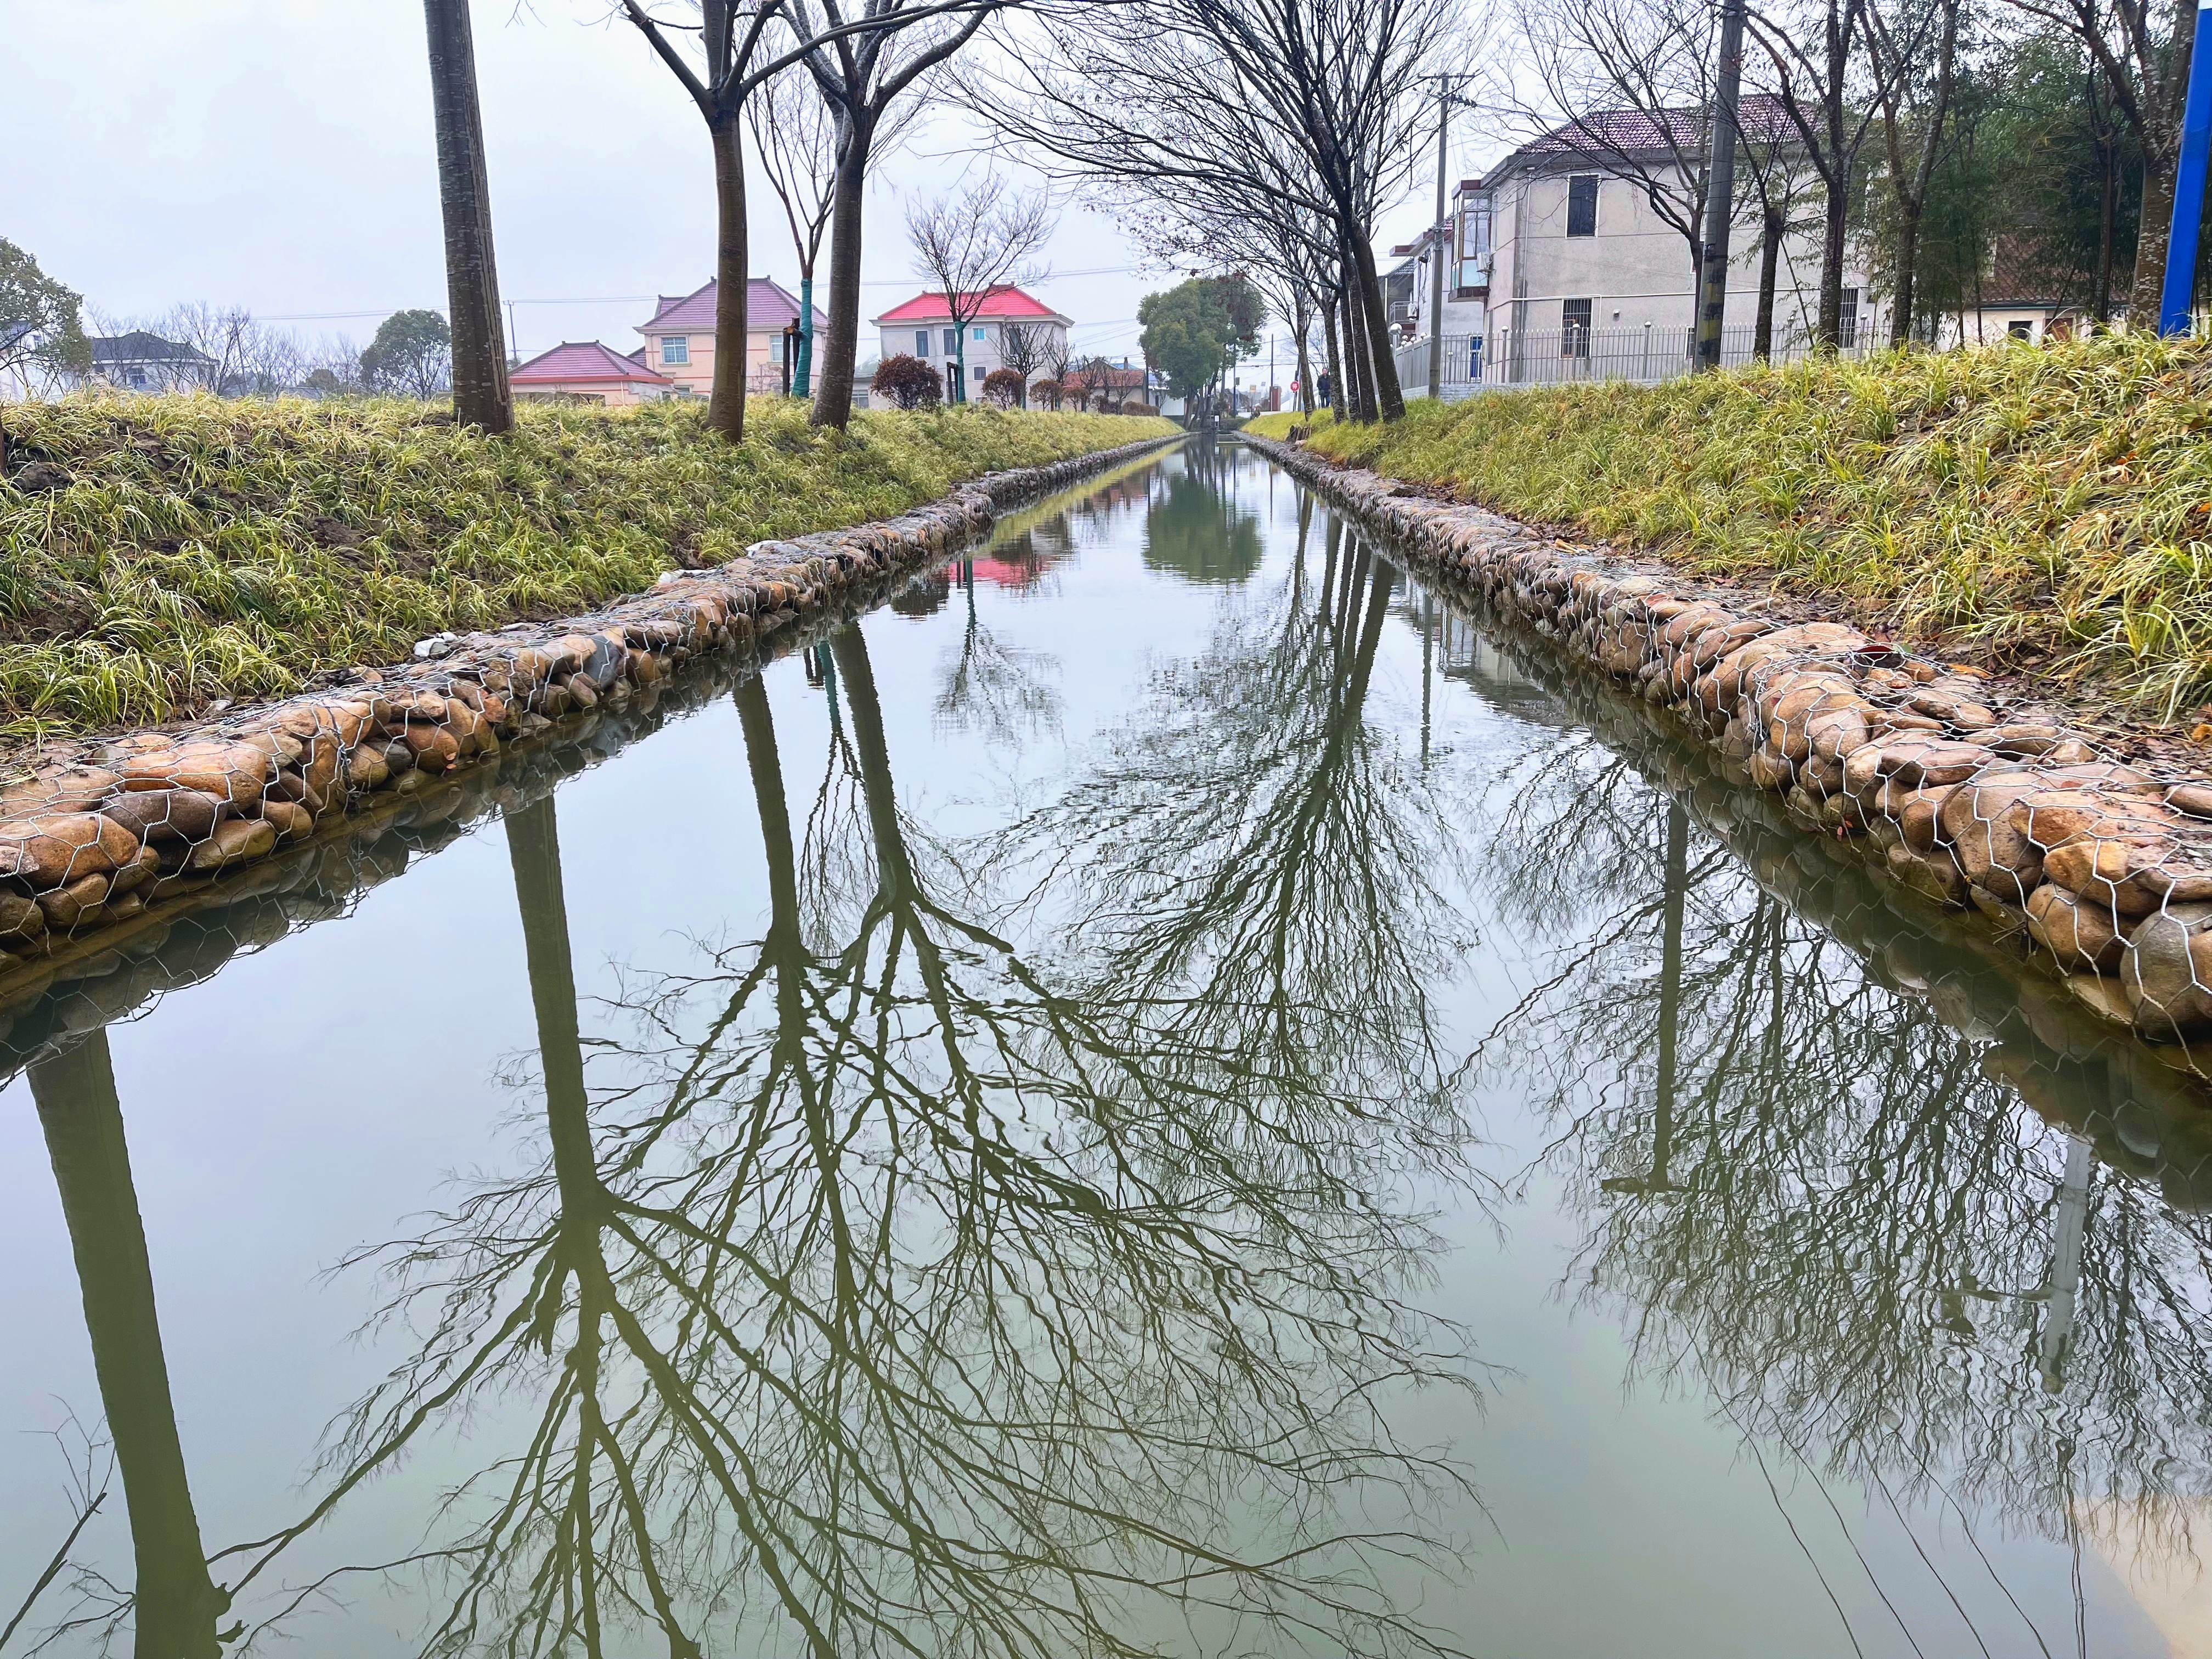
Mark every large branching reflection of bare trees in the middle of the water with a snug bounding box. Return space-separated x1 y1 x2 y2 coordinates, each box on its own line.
220 557 1466 1657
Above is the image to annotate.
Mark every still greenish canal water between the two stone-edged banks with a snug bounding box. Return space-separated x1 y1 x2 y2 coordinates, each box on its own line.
0 447 2212 1659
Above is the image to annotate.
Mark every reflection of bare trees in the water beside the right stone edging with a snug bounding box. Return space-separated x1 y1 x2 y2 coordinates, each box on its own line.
1482 641 2212 1650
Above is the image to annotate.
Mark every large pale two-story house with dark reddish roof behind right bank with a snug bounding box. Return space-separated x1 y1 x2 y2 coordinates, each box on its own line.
1418 95 1882 383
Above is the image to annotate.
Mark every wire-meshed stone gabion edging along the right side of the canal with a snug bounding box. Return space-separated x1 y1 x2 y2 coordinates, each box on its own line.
1243 433 2212 1073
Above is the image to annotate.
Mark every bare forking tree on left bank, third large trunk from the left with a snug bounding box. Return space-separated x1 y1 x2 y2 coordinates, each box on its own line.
783 0 1022 431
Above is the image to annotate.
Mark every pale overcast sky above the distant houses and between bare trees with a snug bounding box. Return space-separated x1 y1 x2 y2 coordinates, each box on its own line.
13 0 1486 380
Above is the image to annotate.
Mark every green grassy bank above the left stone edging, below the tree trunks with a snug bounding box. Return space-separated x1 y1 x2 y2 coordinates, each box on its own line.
0 396 1175 739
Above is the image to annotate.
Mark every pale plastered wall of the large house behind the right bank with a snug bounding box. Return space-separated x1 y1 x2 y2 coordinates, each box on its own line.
1477 157 1878 352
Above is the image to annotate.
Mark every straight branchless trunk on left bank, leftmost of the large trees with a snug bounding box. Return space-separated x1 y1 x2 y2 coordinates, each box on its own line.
422 0 515 431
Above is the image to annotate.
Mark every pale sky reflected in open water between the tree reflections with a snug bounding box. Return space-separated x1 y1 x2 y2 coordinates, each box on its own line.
0 442 2208 1659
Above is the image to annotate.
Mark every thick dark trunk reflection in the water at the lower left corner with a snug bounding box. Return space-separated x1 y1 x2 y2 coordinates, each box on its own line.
31 1031 230 1659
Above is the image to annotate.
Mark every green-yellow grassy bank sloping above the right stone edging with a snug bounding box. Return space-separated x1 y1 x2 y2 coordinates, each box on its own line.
1252 334 2212 719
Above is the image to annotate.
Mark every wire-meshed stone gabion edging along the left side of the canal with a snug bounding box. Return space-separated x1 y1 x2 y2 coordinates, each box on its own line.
0 436 1175 995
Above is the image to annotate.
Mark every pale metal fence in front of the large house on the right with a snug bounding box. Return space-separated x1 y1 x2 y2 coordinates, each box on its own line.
1393 323 1865 403
